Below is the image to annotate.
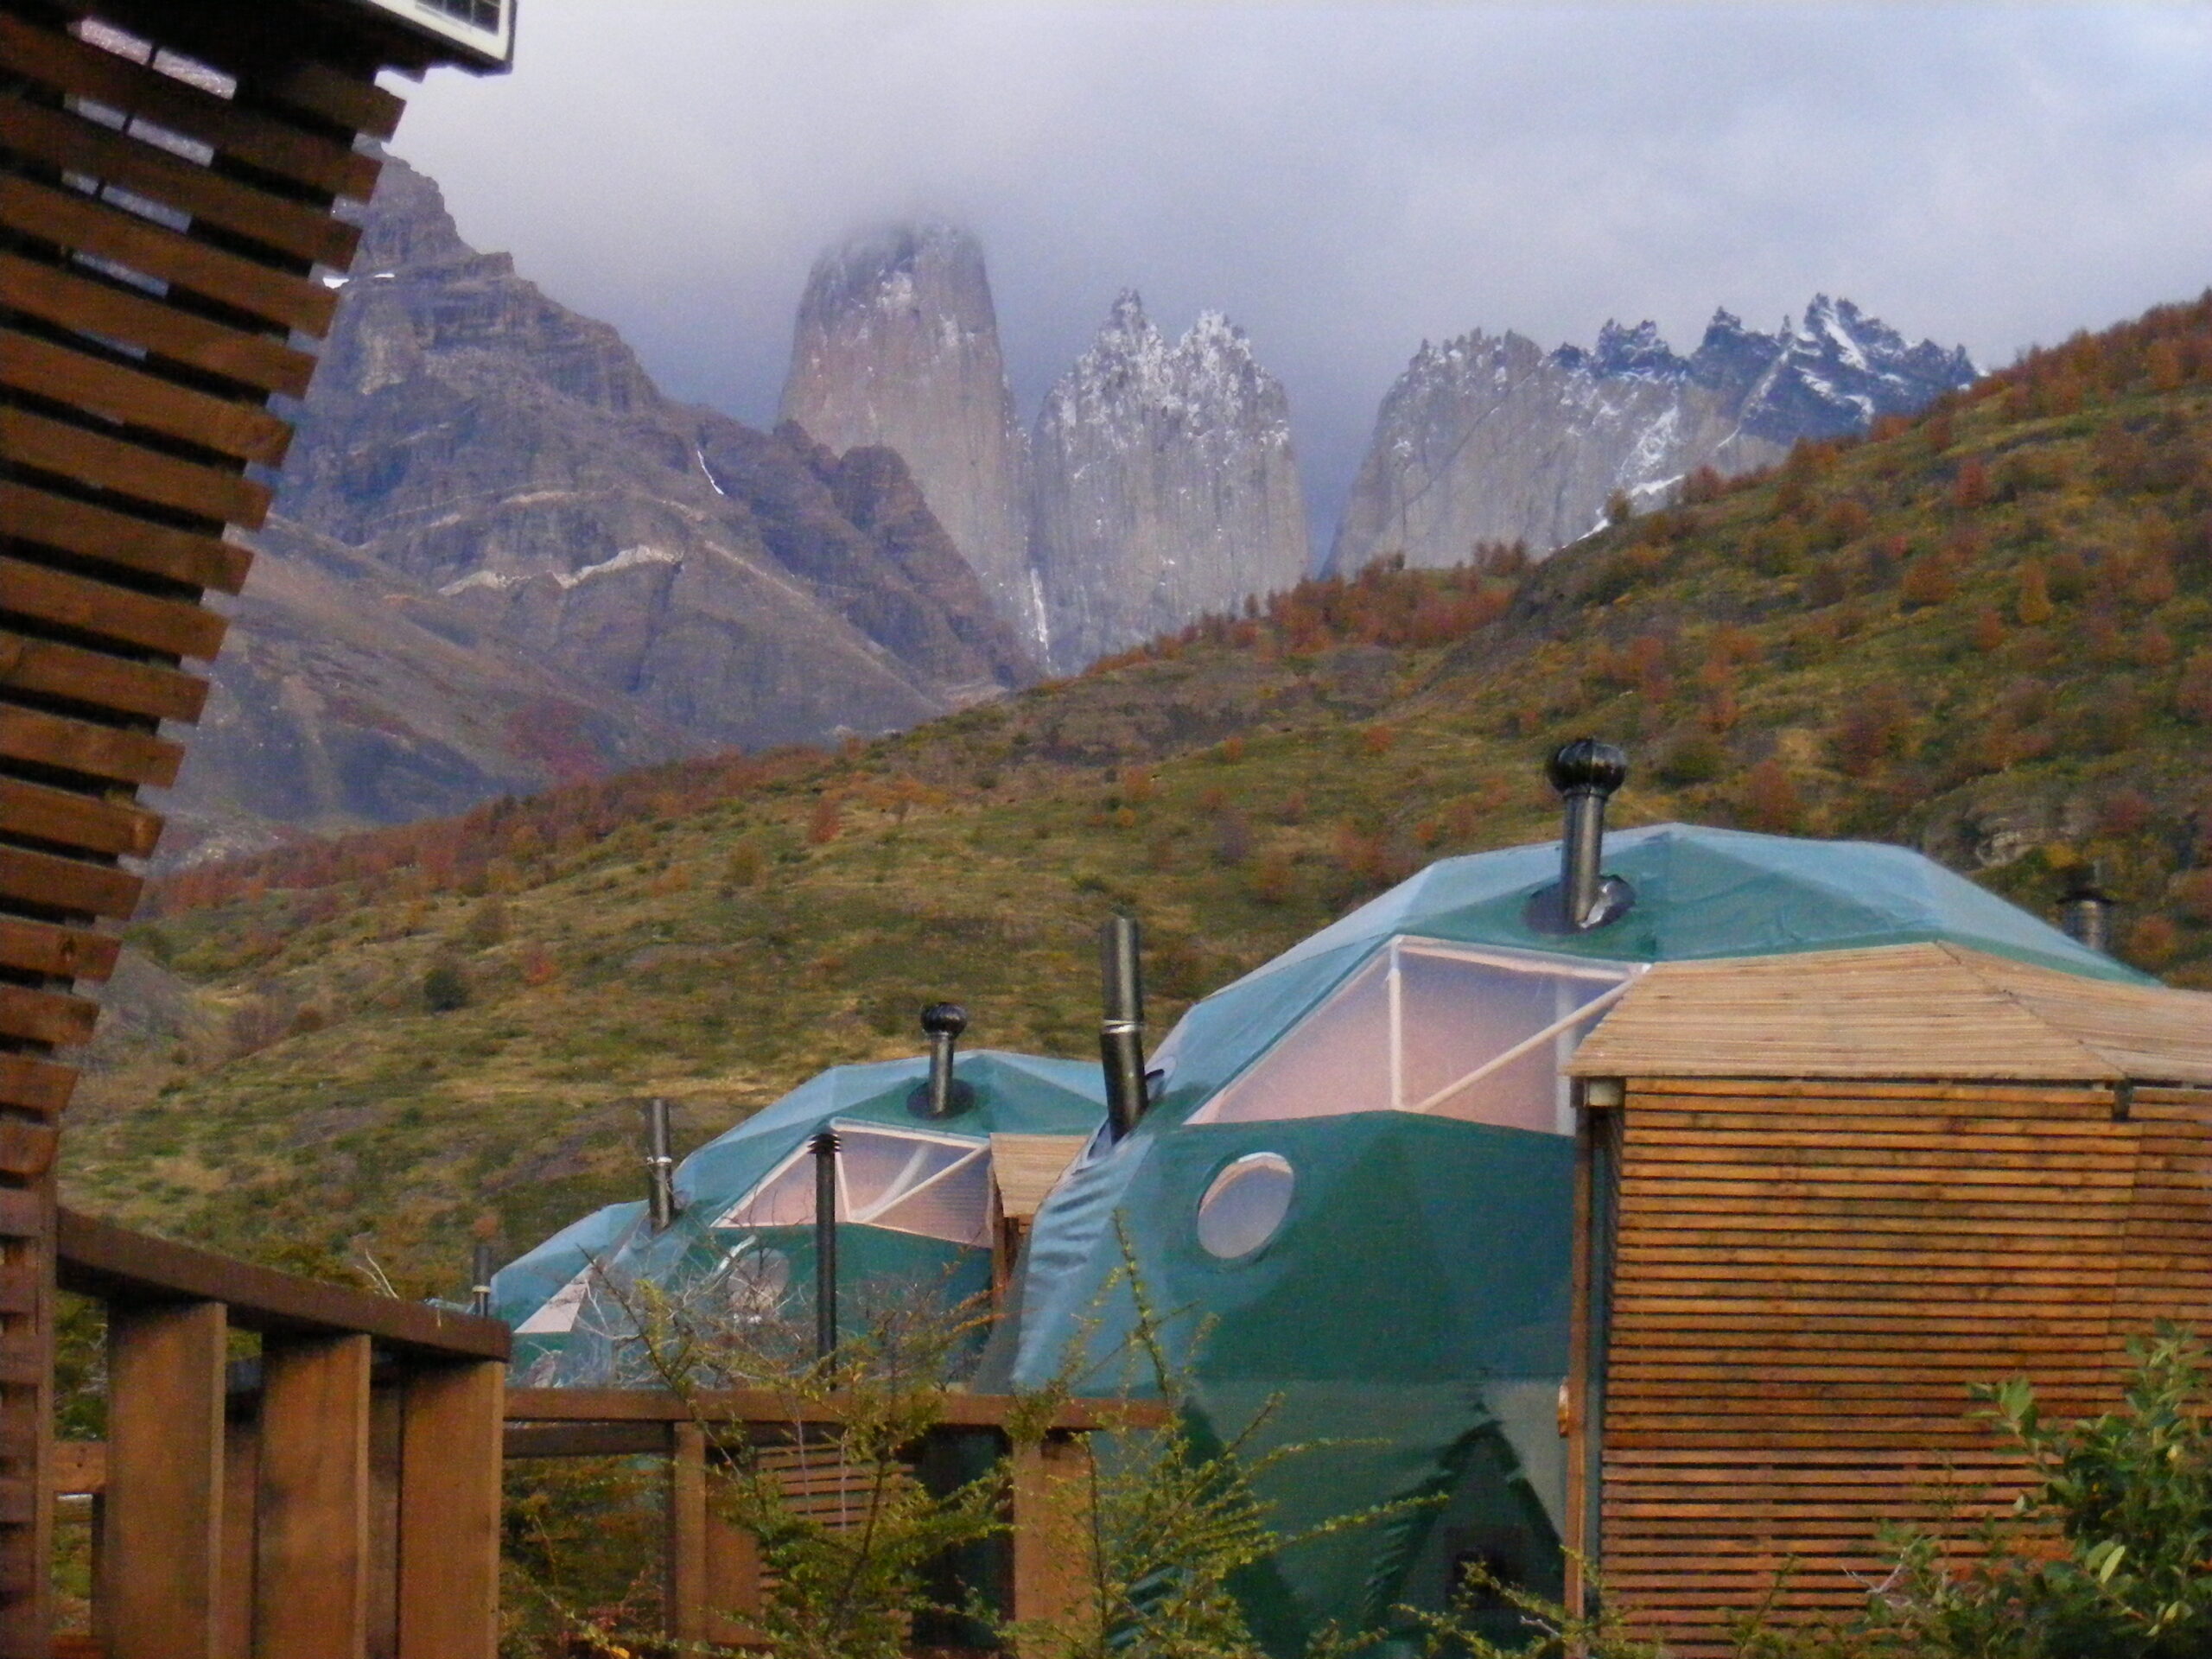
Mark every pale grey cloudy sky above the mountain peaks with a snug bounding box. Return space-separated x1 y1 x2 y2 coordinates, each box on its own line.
394 0 2212 549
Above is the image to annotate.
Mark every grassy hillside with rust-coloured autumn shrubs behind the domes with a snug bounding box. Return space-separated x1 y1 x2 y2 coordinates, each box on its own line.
64 299 2212 1289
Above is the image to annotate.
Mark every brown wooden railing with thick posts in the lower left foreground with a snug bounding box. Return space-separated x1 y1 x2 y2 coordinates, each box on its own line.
55 1210 509 1659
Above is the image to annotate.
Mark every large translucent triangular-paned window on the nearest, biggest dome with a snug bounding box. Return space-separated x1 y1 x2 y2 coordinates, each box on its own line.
1192 940 1632 1133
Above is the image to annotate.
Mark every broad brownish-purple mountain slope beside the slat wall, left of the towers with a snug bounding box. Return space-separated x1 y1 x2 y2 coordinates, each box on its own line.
177 162 1035 862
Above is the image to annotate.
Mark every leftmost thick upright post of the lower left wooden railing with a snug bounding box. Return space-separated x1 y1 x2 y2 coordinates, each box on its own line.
99 1303 228 1659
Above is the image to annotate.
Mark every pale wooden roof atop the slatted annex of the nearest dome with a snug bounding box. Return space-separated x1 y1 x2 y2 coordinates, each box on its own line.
1568 943 2212 1084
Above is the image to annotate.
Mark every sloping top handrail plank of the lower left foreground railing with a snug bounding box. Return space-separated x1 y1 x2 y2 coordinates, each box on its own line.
58 1210 509 1360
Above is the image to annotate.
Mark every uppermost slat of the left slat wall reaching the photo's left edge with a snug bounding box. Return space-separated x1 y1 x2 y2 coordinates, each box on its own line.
0 17 380 201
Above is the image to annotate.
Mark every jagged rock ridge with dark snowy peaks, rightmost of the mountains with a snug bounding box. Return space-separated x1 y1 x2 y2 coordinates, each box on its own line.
1330 294 1975 573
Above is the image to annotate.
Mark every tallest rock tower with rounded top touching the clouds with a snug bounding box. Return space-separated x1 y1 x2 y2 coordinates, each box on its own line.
783 224 1044 655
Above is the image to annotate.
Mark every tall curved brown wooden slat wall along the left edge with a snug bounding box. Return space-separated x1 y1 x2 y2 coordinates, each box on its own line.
0 0 400 1659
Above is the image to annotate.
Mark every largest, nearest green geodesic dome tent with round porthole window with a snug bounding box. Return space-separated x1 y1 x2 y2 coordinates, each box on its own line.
987 825 2145 1652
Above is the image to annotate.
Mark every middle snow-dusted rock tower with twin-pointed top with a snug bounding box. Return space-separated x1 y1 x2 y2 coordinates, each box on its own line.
1031 292 1310 672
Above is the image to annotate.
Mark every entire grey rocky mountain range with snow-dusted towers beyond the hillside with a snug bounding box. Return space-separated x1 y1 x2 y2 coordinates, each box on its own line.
163 159 1974 862
